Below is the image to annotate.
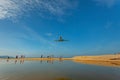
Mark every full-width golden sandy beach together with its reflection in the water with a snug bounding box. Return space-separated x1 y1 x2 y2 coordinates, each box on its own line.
0 54 120 67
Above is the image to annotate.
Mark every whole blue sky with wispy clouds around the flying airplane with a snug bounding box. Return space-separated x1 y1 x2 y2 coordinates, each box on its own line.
0 0 120 57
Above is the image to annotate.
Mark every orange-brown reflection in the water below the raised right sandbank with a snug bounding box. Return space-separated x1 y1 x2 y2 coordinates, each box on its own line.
73 60 120 67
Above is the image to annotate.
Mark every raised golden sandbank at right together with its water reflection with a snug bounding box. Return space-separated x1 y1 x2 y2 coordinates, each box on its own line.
73 54 120 67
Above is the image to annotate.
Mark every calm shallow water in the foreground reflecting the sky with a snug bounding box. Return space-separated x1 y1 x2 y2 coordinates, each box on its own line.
0 60 120 80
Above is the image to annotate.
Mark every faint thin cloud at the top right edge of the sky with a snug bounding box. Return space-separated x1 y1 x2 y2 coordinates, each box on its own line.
93 0 120 8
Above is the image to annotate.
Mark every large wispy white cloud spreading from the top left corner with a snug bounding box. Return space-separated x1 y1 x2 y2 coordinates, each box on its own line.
0 0 77 19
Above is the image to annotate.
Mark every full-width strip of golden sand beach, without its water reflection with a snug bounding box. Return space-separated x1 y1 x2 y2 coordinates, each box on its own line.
0 54 120 62
